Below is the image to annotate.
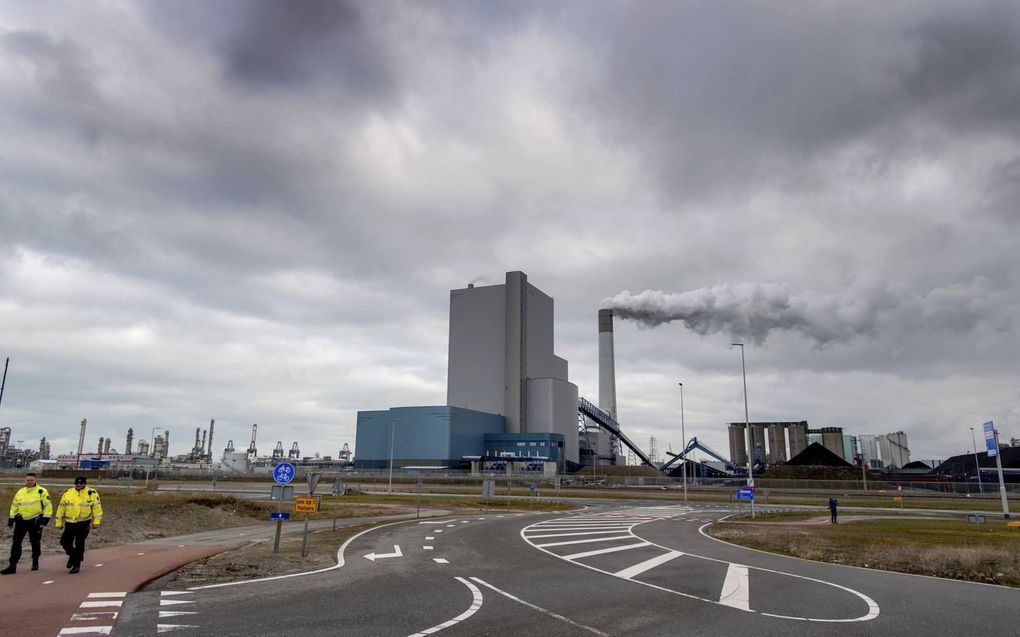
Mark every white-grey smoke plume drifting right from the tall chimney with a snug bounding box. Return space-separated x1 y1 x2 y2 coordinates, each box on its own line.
602 280 1013 346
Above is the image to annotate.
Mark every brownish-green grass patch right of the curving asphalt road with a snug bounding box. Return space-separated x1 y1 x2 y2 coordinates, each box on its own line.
708 516 1020 587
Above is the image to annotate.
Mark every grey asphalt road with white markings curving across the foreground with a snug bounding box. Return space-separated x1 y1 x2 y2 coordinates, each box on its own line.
112 502 1020 637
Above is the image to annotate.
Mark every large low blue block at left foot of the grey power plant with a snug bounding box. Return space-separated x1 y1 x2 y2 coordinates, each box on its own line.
354 406 506 469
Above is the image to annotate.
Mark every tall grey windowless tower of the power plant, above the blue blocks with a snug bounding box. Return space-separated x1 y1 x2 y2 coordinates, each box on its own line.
447 272 578 463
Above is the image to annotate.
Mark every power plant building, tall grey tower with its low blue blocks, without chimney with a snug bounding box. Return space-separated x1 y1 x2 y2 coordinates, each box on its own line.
355 272 578 469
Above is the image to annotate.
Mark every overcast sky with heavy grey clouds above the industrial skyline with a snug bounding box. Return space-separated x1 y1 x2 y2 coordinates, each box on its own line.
0 0 1020 466
